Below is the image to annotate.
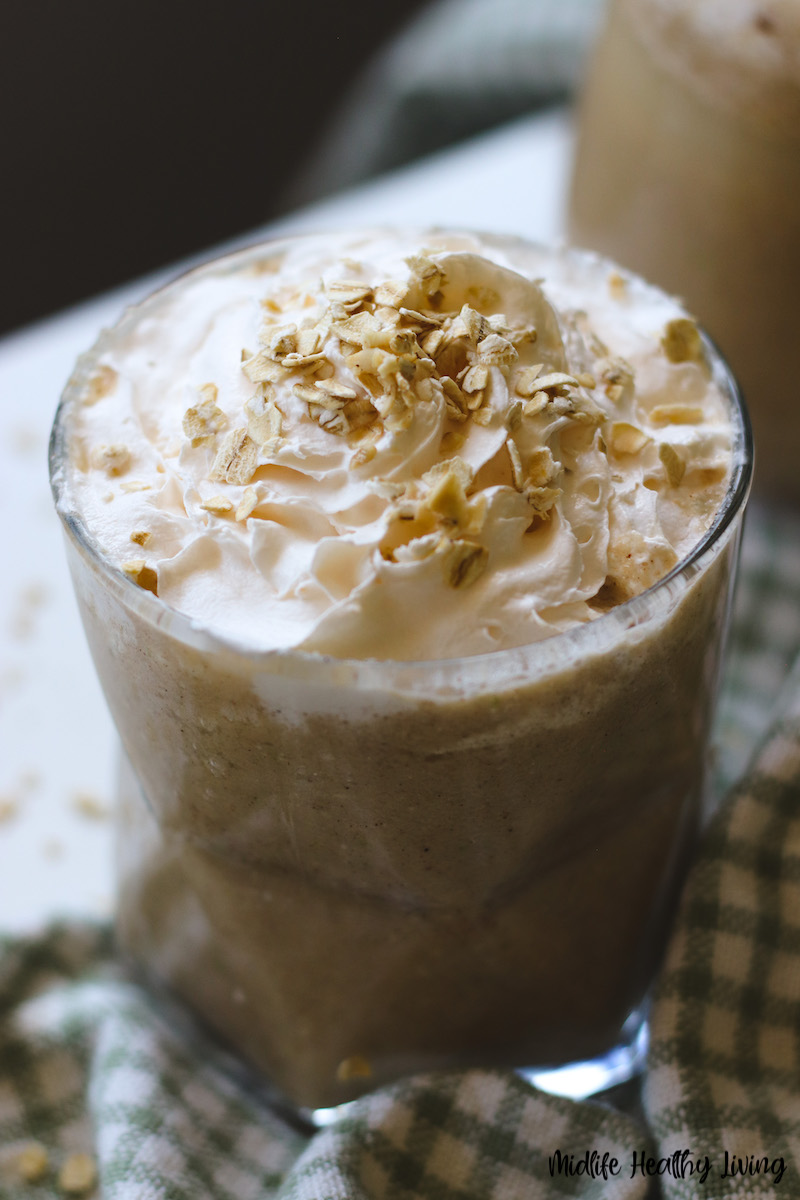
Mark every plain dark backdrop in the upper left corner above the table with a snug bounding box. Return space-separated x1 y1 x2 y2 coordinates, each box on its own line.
0 0 426 331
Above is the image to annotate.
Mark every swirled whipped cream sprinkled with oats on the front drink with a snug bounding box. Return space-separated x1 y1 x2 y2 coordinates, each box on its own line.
61 232 733 660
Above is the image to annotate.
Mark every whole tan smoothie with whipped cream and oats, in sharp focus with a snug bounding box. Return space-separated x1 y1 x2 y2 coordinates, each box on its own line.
52 232 750 1109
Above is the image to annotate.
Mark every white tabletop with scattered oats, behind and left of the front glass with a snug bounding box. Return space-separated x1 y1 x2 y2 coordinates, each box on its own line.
0 112 571 934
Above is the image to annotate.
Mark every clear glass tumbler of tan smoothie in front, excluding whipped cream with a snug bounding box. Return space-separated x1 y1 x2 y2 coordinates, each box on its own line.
52 238 752 1110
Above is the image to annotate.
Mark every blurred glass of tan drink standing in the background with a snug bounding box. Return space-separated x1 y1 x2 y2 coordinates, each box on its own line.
570 0 800 504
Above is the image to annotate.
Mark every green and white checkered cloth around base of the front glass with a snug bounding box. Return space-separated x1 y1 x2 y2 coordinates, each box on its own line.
0 501 800 1200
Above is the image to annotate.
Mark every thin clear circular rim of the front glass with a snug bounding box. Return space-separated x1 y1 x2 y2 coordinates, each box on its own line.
48 227 754 690
